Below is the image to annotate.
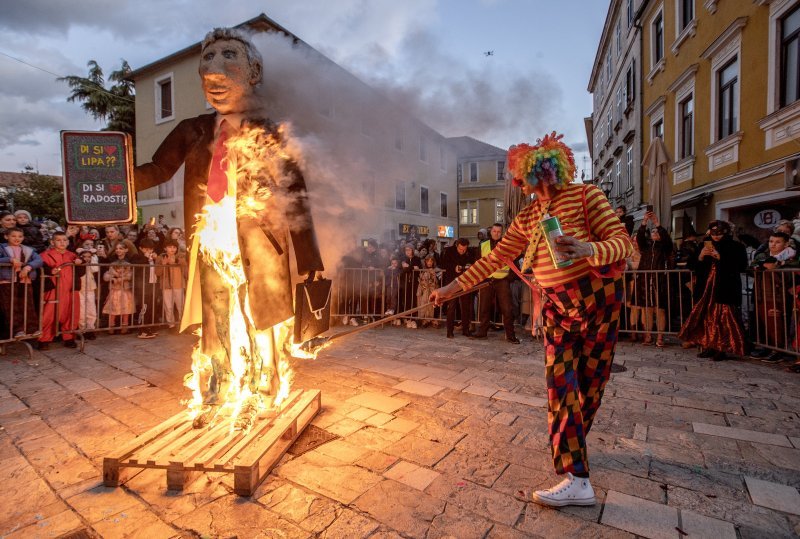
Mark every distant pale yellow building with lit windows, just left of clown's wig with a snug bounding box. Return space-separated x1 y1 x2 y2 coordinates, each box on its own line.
447 137 506 245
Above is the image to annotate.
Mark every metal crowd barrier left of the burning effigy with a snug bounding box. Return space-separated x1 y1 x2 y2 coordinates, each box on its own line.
0 263 185 354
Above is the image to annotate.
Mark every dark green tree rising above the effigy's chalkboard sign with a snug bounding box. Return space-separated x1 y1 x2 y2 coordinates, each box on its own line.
58 59 136 137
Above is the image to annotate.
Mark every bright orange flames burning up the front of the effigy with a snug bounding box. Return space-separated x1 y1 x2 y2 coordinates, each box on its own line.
184 123 316 429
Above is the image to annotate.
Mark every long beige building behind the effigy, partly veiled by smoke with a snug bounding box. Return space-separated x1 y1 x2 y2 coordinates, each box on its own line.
131 14 458 248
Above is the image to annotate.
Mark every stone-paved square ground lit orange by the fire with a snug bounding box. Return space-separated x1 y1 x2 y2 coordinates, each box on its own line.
0 328 800 539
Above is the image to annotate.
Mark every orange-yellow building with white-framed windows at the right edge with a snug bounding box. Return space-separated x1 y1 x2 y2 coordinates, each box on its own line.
637 0 800 238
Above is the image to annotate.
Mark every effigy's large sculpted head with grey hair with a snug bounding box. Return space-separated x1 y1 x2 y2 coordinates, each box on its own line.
198 28 264 114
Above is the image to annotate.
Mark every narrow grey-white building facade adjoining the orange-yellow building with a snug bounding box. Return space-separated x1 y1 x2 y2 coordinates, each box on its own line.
585 0 643 219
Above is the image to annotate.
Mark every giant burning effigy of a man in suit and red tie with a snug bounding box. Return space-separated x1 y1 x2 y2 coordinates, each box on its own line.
135 28 324 430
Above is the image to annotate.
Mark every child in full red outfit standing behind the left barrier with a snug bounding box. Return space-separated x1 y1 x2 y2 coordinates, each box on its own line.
39 232 85 350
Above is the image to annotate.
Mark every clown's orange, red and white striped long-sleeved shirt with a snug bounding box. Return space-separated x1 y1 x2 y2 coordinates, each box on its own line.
458 183 633 290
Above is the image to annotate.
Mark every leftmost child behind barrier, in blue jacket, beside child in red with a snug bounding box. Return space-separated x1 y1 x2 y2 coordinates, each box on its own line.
0 228 43 339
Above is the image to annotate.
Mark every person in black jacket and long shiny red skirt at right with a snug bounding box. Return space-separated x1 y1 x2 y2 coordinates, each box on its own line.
678 221 747 361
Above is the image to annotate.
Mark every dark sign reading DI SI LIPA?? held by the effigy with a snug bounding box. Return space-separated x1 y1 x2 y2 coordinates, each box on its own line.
61 131 136 224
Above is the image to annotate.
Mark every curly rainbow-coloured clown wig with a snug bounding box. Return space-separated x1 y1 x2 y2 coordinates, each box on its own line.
508 131 575 189
